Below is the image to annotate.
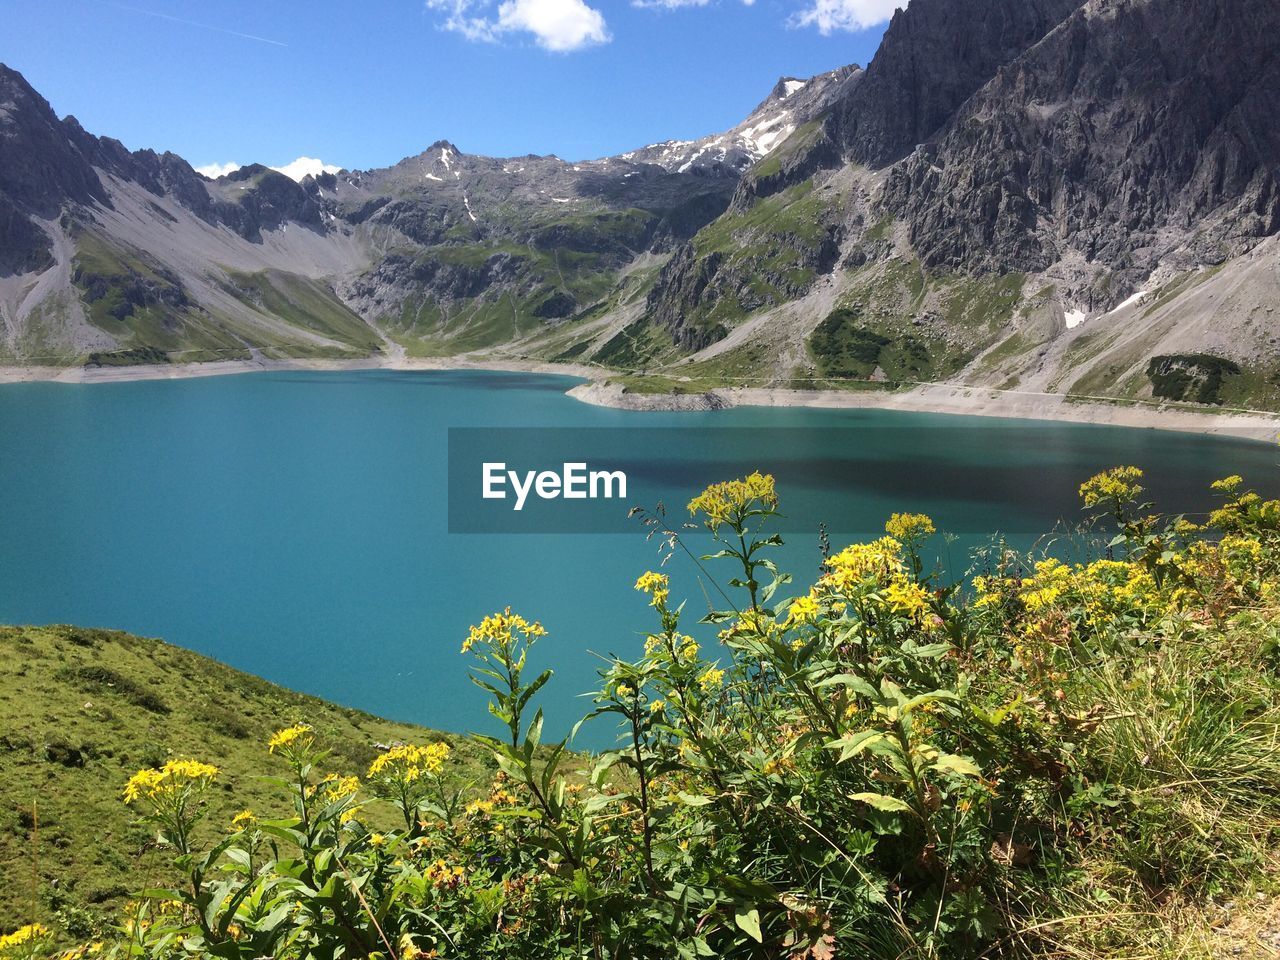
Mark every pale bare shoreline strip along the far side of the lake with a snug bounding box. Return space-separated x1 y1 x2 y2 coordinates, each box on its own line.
0 357 1280 442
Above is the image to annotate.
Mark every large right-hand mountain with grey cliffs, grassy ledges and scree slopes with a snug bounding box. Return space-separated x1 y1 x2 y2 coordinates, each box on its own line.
648 0 1280 406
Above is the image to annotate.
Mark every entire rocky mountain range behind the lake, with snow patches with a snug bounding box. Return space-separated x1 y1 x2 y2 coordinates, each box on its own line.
0 0 1280 408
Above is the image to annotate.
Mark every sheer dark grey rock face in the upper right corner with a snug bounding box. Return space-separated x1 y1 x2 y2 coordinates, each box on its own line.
884 0 1280 277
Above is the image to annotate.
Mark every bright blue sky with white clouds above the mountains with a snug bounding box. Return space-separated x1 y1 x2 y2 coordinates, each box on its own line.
0 0 905 169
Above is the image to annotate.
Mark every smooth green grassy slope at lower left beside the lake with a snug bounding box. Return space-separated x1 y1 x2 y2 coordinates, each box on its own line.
0 626 488 936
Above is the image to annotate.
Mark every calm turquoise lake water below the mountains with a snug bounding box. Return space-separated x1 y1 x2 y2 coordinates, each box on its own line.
0 371 1280 742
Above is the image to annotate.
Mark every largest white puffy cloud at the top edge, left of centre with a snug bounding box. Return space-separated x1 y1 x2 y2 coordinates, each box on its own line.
426 0 612 52
